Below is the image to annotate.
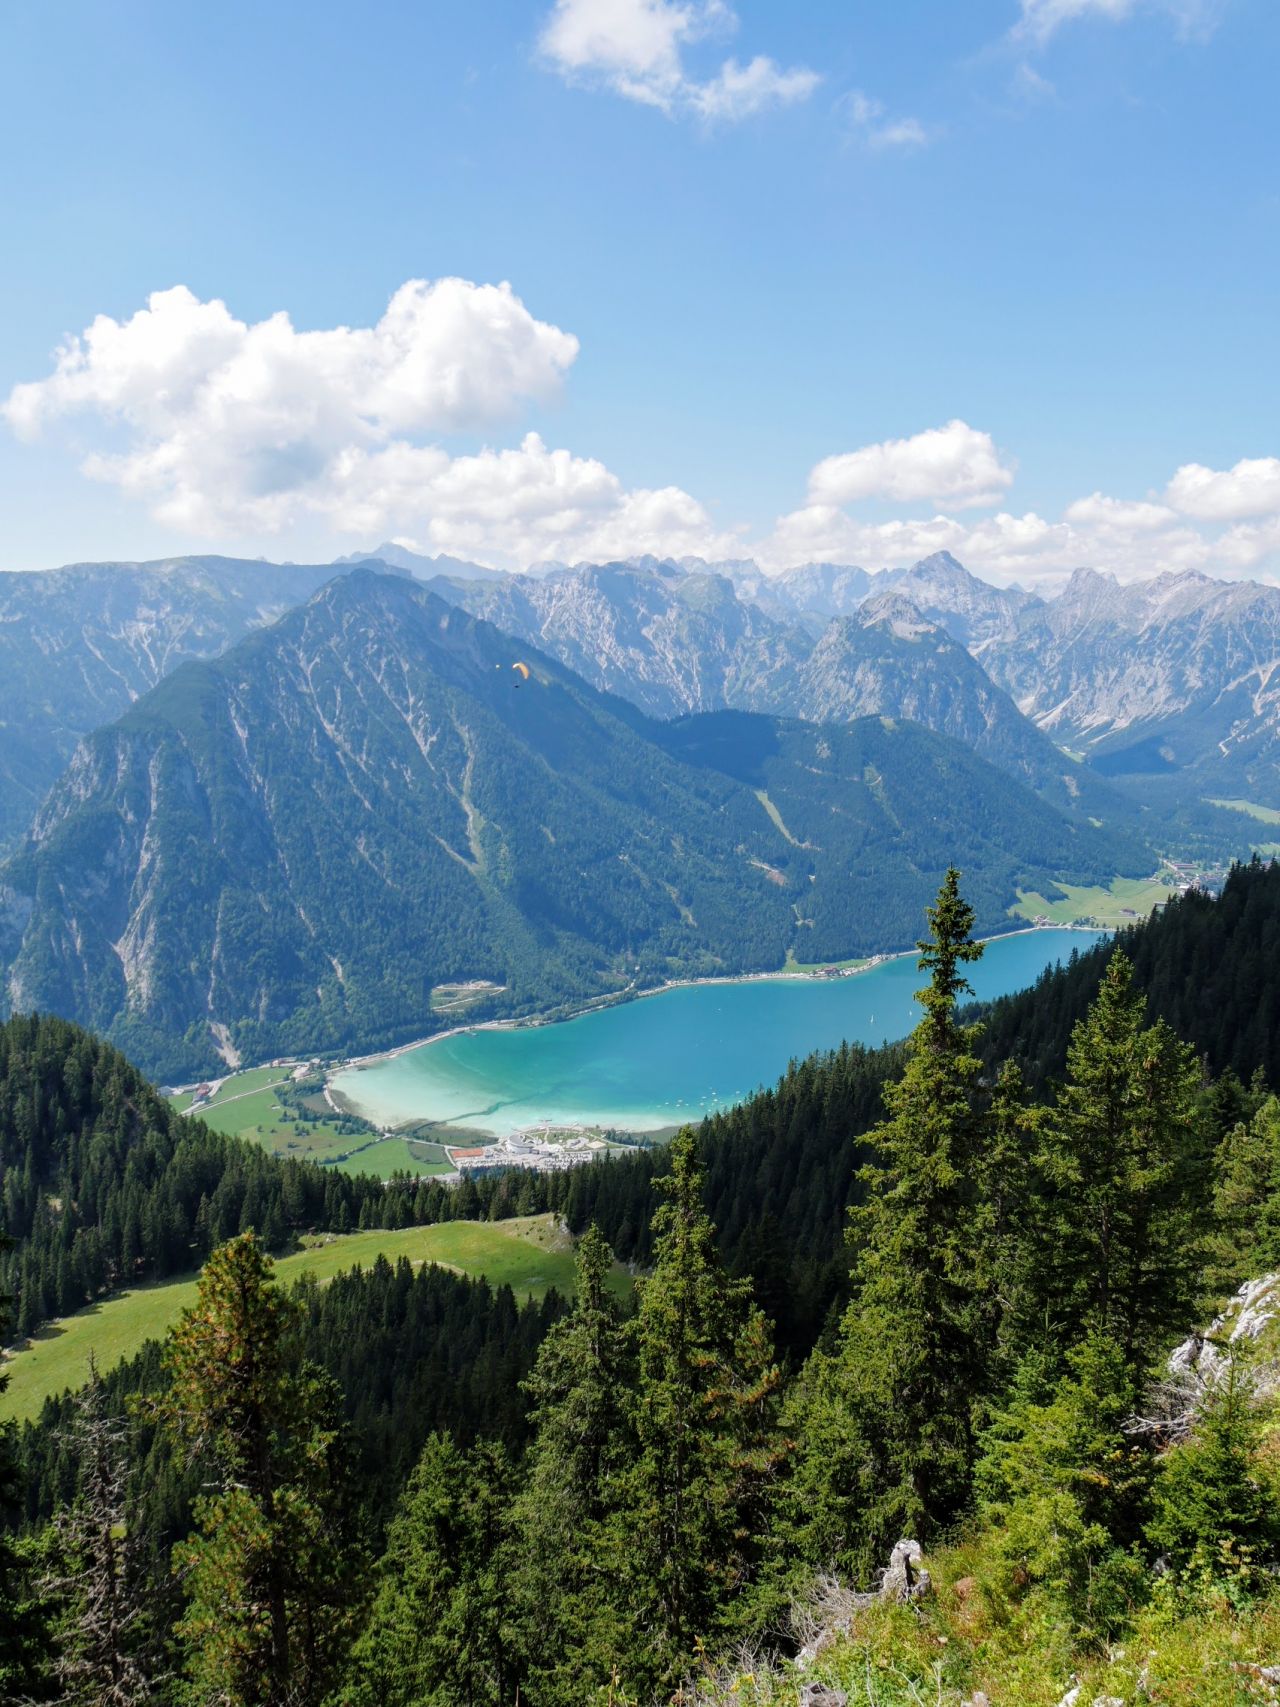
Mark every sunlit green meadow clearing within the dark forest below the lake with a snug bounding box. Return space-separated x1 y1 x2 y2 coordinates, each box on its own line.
0 1215 631 1420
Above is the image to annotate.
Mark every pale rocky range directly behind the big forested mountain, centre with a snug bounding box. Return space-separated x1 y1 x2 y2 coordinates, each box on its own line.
432 563 1137 839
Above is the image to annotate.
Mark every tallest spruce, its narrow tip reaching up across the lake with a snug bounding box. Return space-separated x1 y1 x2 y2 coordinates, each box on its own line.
788 869 992 1577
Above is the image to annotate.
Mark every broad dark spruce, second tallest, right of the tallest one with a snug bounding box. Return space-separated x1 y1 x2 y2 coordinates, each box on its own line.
1034 953 1208 1369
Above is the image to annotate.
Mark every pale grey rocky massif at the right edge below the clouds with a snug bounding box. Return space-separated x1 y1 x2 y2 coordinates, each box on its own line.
983 570 1280 792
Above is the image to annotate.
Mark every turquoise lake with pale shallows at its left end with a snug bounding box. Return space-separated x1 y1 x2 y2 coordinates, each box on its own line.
331 930 1101 1135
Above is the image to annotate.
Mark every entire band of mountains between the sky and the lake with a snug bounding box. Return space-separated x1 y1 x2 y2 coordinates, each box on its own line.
0 546 1280 1077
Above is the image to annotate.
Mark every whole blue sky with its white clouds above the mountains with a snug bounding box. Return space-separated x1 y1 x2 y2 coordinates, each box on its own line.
0 0 1280 582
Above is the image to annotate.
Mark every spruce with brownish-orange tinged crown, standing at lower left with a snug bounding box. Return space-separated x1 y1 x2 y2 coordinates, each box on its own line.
159 1232 360 1707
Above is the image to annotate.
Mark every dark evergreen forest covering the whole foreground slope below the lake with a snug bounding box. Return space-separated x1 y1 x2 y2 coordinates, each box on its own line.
0 860 1280 1707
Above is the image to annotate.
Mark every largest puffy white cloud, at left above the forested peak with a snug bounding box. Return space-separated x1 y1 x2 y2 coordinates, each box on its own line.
3 278 579 531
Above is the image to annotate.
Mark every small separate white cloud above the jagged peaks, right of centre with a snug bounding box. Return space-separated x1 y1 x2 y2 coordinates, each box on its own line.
809 420 1014 509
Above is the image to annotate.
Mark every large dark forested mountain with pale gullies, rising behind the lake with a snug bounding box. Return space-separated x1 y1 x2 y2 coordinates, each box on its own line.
0 570 1140 1077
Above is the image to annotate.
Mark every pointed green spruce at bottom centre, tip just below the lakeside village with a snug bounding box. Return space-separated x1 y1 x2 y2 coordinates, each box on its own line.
625 1128 783 1681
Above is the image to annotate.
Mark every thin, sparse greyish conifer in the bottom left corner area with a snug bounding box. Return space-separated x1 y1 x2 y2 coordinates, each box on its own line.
43 1359 157 1707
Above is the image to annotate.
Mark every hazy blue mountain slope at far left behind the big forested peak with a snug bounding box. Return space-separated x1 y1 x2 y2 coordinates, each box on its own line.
0 556 361 848
